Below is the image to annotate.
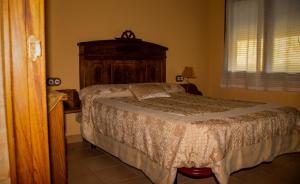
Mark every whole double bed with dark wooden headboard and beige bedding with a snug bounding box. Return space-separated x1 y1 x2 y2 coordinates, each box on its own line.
78 34 300 184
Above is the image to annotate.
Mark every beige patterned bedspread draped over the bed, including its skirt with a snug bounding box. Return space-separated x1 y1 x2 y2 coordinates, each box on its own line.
81 93 300 184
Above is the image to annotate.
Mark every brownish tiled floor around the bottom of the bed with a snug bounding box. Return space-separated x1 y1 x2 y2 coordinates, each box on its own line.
67 142 300 184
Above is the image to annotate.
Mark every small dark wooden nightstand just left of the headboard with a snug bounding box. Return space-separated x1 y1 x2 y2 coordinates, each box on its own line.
57 89 81 114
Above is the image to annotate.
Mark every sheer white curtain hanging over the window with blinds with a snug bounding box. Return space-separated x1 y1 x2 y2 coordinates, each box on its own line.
221 0 300 91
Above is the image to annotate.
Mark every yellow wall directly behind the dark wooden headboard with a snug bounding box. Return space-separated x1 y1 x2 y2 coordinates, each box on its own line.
46 0 209 135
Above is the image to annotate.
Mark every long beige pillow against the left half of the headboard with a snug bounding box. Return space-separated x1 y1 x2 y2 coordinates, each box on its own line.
79 84 132 100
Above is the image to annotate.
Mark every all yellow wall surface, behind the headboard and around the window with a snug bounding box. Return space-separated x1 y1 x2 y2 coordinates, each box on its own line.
46 0 300 135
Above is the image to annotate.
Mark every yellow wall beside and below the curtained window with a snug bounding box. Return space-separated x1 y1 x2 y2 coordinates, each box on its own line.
205 0 300 110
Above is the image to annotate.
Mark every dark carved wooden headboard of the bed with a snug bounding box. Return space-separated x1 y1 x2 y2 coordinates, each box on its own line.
78 31 168 88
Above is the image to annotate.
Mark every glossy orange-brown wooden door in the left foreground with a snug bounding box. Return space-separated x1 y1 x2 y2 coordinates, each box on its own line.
0 0 50 184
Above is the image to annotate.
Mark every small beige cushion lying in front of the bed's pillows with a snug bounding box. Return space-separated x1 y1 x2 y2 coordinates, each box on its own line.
129 83 170 101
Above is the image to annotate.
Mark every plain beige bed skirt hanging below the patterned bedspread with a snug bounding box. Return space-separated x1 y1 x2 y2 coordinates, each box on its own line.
82 126 300 184
